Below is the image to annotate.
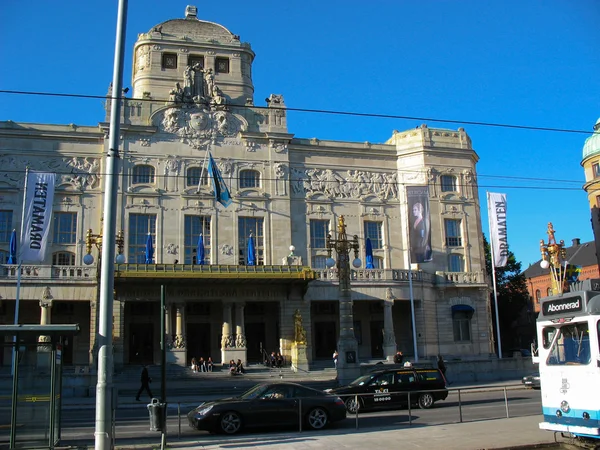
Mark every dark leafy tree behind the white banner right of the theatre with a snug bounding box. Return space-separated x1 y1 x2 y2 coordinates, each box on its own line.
483 235 535 350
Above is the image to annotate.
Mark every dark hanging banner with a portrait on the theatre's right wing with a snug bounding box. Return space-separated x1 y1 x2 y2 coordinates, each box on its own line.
406 186 433 263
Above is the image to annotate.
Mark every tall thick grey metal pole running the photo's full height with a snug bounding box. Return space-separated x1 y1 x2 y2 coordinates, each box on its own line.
94 0 127 450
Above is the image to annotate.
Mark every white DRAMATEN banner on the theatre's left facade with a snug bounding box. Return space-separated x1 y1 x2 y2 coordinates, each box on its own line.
19 172 56 262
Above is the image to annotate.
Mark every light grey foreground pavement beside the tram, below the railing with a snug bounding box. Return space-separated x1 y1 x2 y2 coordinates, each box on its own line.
57 415 563 450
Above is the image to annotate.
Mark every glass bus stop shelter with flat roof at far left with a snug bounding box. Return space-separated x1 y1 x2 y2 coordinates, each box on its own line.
0 324 79 449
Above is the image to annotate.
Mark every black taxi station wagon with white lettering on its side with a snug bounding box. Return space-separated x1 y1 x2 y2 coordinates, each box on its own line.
330 367 448 414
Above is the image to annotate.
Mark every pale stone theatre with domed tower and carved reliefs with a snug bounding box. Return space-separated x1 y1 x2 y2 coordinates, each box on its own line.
0 7 493 366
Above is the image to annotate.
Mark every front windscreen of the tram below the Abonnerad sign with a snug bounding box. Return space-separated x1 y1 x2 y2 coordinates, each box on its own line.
548 323 591 366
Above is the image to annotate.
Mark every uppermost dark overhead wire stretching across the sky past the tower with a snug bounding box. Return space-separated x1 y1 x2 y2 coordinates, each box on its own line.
0 89 600 135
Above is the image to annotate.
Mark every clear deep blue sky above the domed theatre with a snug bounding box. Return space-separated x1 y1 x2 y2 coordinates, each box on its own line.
0 0 600 268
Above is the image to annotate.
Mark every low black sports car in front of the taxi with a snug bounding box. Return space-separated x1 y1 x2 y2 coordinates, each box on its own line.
188 383 346 434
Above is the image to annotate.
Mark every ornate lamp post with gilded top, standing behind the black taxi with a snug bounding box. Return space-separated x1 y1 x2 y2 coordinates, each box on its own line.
325 216 361 384
